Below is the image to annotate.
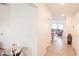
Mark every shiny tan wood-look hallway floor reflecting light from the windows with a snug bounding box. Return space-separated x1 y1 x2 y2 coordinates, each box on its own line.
45 37 76 56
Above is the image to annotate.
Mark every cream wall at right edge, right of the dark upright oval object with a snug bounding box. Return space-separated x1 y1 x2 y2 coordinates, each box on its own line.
73 12 79 55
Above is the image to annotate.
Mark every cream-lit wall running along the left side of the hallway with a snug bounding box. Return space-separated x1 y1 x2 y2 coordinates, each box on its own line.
35 4 52 55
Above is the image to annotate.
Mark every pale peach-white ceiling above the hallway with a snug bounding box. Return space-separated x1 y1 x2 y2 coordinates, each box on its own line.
45 3 79 16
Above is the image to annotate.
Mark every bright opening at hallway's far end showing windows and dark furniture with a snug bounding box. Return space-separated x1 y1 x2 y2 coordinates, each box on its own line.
51 15 66 40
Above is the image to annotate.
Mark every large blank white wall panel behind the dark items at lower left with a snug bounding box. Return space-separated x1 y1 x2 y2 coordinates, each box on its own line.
9 4 38 55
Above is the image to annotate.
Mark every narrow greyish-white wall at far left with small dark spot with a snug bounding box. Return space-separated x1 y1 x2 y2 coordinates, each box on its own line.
0 5 9 48
